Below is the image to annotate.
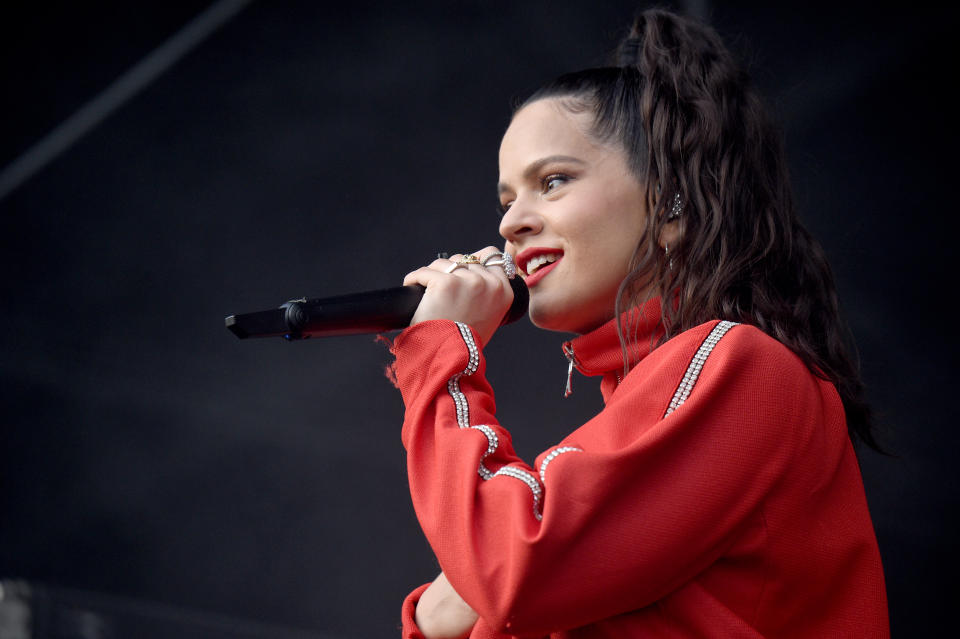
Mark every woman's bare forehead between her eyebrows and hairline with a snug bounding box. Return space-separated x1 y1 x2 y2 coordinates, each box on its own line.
500 98 609 173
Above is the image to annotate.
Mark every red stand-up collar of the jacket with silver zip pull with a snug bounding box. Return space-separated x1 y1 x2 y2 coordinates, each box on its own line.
563 297 663 402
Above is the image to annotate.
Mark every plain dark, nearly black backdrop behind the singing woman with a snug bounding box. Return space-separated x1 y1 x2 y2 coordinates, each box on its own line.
0 0 960 637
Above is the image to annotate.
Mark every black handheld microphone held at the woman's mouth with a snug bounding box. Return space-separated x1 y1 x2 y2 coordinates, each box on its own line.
224 277 530 340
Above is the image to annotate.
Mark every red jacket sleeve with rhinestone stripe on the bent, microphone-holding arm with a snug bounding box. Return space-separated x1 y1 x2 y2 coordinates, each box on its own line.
393 320 842 636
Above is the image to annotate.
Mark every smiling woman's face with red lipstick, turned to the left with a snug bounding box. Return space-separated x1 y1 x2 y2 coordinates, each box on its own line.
498 99 647 333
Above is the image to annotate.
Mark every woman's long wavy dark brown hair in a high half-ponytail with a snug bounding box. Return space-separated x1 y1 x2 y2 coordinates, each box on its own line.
518 9 881 450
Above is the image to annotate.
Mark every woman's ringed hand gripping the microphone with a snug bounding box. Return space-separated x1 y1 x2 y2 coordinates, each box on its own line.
403 246 513 344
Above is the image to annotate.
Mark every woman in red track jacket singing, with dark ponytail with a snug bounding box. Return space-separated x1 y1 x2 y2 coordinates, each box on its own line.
392 6 889 638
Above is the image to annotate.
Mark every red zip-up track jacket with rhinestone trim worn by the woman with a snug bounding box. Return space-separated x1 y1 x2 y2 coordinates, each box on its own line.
392 303 889 639
